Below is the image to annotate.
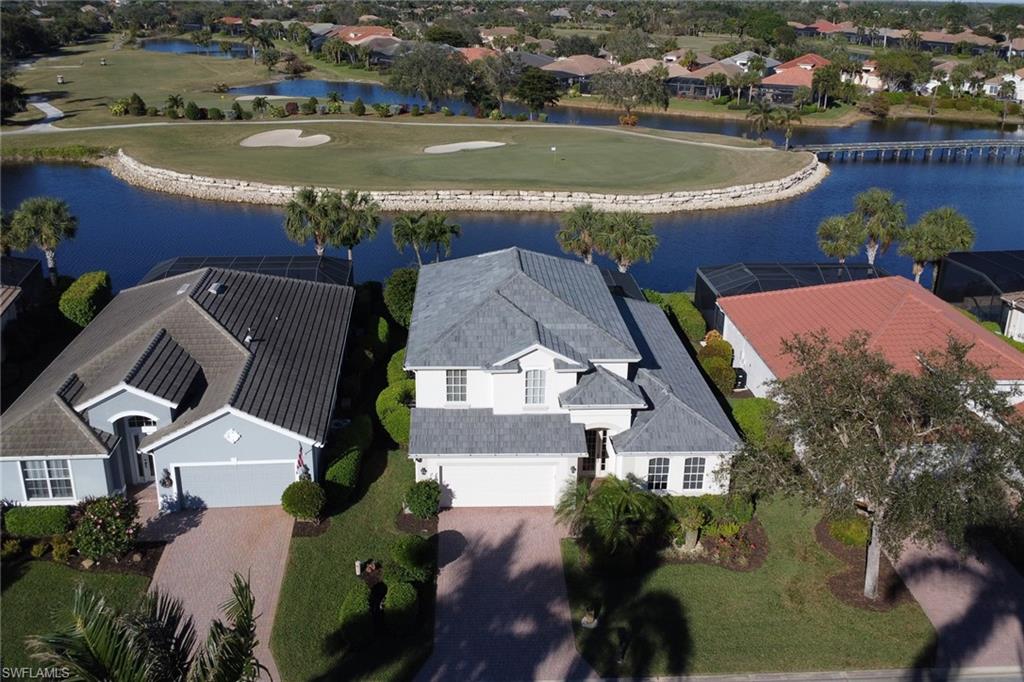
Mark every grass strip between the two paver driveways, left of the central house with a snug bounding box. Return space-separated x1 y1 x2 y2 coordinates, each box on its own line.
270 452 433 682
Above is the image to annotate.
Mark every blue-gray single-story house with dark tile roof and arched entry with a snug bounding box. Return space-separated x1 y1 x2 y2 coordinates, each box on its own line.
0 259 354 509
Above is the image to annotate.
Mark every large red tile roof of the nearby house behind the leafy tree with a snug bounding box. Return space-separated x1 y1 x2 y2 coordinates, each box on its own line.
718 276 1024 380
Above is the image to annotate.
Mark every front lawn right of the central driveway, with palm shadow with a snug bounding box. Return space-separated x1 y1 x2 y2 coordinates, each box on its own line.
562 500 934 676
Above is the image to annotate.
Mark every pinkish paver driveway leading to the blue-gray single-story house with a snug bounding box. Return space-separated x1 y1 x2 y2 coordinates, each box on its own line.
143 507 293 680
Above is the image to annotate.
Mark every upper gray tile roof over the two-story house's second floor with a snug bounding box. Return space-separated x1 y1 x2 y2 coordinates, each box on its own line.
406 248 639 368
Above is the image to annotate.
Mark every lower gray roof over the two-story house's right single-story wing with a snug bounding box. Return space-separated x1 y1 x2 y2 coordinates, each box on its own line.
611 298 739 454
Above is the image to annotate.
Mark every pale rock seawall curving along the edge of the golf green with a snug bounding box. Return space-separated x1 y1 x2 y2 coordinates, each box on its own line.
98 150 828 213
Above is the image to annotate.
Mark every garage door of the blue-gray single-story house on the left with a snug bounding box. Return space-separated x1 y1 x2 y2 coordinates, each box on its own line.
176 462 295 508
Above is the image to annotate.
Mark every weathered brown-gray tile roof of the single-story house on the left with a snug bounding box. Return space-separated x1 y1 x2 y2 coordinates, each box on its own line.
0 261 354 457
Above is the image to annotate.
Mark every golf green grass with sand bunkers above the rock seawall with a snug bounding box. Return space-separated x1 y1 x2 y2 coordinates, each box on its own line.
4 115 810 193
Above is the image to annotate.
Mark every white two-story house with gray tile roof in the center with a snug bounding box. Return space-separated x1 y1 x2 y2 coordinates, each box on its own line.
406 248 739 507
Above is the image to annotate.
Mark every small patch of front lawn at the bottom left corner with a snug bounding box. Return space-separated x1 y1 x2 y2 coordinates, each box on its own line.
0 560 150 669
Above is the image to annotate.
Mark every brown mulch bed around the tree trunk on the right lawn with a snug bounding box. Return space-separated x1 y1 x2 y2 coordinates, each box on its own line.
814 519 913 611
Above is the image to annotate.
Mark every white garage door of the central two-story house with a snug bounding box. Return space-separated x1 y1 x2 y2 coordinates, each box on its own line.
440 462 556 507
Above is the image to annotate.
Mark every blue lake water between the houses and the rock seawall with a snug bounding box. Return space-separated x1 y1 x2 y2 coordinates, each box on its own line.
0 161 1024 290
